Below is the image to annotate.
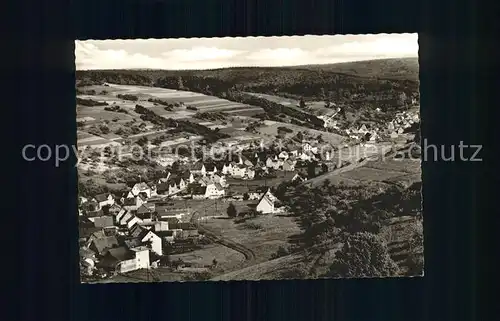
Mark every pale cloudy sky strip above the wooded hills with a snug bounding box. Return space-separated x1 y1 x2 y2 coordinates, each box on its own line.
75 34 418 70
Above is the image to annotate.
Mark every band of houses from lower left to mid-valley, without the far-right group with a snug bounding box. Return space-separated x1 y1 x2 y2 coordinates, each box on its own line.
79 136 340 275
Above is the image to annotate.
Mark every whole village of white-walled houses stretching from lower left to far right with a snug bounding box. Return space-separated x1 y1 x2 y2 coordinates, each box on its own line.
79 104 418 280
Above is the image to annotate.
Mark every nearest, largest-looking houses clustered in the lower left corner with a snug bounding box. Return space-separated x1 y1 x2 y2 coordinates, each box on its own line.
79 188 199 276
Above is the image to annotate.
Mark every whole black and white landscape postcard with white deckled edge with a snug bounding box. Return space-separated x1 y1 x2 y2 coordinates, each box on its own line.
74 34 424 283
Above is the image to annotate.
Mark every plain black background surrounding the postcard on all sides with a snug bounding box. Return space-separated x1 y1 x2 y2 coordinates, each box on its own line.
13 0 490 321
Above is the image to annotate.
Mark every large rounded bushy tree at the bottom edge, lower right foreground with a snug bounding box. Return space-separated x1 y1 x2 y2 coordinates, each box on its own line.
328 232 399 278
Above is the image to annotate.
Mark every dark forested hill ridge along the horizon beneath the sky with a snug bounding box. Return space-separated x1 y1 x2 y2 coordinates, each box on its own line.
76 58 419 126
